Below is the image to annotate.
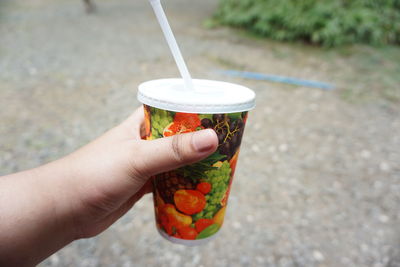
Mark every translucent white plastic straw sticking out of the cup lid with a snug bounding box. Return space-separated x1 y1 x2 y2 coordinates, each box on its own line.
150 0 193 90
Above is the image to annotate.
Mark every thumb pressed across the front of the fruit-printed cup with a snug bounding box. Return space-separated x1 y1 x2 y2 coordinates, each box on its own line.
133 129 218 179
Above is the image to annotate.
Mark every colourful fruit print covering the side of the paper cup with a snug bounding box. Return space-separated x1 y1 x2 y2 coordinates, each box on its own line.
144 105 247 244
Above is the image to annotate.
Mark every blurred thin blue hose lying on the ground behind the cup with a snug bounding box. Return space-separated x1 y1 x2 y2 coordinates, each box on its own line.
217 70 335 91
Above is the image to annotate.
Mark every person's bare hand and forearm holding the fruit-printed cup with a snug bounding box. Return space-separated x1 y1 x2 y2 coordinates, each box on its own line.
0 108 218 266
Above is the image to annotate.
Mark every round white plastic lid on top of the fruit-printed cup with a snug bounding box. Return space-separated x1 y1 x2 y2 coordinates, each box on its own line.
137 79 256 114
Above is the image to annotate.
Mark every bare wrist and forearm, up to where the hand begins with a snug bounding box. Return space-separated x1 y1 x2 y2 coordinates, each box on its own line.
0 163 74 266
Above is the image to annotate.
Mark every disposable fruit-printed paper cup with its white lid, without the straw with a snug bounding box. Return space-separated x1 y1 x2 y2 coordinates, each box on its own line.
138 79 255 246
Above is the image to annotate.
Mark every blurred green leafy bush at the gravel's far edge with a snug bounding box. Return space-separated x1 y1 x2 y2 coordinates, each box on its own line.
215 0 400 47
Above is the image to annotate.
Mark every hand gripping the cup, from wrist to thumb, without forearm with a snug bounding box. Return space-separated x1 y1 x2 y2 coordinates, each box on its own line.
61 107 218 238
